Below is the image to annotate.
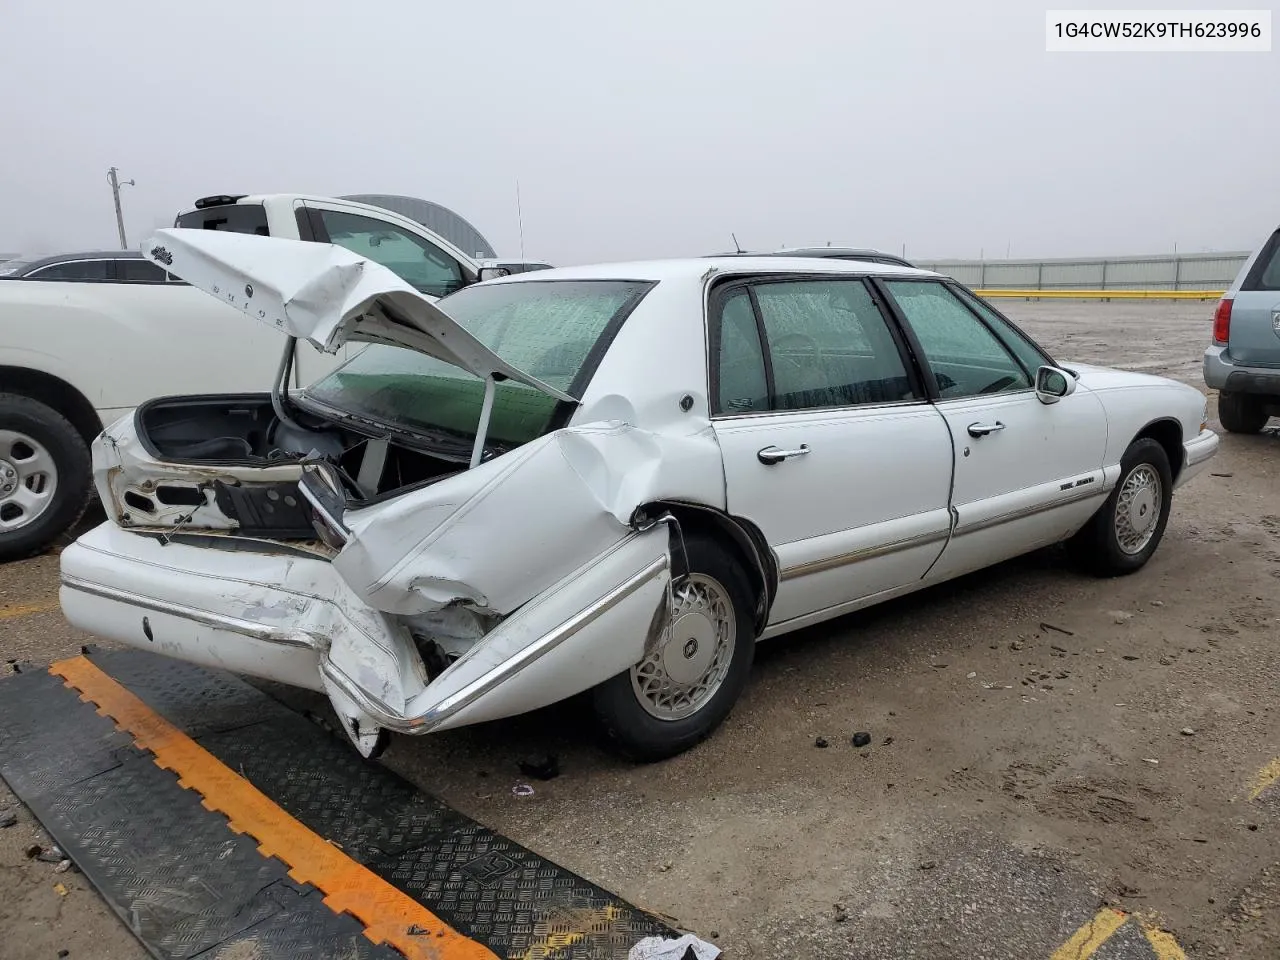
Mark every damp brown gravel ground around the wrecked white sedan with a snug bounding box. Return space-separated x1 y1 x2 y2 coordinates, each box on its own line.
0 302 1280 960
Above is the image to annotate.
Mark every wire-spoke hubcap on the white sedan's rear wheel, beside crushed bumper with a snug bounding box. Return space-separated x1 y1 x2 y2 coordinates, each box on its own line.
631 573 737 721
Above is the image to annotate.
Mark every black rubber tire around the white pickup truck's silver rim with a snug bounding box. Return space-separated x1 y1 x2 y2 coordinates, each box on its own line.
0 393 92 562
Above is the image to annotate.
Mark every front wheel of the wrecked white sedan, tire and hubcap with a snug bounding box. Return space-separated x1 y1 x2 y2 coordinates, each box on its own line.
1069 436 1174 576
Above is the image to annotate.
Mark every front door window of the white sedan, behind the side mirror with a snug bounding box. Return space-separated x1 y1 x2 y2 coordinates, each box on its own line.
884 280 1032 399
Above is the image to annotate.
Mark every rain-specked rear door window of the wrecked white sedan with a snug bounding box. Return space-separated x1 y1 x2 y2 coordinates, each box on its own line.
718 278 919 413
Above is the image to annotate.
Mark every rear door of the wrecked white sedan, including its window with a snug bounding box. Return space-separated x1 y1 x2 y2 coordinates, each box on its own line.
708 276 952 632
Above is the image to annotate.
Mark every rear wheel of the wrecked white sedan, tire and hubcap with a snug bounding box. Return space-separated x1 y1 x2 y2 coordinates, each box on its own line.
591 534 755 760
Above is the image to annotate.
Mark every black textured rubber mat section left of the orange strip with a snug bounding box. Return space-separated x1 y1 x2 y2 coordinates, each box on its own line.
0 671 398 960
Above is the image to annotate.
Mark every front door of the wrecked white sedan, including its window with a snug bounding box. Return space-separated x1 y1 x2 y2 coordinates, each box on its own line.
883 280 1107 580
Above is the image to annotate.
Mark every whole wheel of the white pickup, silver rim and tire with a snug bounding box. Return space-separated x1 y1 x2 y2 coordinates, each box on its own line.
0 393 92 562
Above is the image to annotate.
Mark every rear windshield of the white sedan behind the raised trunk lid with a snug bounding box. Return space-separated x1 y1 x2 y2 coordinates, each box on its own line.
305 280 653 445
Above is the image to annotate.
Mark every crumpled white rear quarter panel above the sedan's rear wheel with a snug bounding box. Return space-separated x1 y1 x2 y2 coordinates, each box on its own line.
333 422 724 616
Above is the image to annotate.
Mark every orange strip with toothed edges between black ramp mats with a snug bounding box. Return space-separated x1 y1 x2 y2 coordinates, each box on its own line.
49 657 498 960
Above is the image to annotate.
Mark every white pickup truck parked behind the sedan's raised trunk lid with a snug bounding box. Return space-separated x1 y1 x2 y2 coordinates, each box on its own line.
0 193 508 562
